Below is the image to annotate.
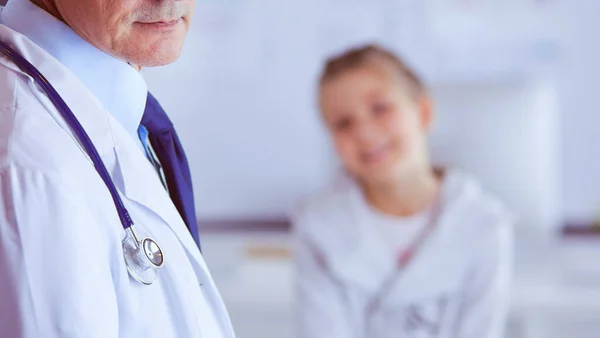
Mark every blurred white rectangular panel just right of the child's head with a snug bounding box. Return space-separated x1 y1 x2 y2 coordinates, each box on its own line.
431 79 562 228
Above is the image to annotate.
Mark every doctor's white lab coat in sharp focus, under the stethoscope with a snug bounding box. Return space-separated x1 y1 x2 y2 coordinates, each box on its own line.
0 25 234 338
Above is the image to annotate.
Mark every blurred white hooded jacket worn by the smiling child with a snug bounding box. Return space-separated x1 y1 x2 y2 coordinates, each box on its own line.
293 169 513 338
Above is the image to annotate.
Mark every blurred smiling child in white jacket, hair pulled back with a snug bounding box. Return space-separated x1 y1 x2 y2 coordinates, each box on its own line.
293 45 512 338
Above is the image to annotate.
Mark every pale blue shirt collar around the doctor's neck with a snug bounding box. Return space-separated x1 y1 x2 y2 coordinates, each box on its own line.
0 0 148 139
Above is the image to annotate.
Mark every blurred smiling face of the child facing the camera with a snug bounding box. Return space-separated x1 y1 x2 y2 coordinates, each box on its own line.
320 67 431 183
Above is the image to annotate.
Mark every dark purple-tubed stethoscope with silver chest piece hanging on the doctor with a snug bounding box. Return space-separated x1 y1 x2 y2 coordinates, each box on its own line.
0 41 165 285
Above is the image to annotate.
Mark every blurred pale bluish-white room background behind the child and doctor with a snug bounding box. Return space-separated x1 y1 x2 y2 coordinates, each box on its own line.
145 0 600 338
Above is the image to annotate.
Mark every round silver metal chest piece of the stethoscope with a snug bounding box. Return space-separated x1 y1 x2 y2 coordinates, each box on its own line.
123 226 165 285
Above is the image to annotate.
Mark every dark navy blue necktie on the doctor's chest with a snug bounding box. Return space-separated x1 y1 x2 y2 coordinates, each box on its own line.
141 93 200 247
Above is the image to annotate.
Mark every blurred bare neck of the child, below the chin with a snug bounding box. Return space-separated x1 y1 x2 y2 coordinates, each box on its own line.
362 167 442 217
